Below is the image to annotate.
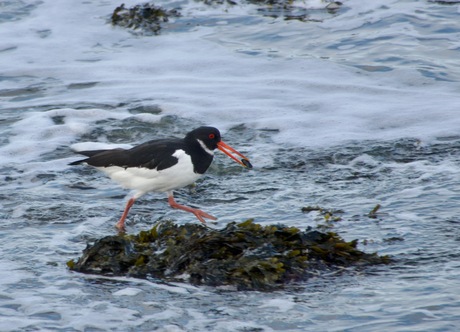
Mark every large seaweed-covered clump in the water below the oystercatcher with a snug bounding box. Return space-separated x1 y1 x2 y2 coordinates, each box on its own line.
68 220 389 290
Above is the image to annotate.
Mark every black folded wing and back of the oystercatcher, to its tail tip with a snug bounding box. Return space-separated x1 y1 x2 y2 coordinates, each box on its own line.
69 139 183 170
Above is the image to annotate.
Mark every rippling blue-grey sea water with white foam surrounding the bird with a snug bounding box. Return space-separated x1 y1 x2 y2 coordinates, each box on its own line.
0 0 460 331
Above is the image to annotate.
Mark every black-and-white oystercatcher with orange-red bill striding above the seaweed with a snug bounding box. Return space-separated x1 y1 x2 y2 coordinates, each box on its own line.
69 127 252 230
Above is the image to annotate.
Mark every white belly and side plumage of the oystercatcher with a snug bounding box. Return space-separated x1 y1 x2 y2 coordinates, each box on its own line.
98 150 201 197
